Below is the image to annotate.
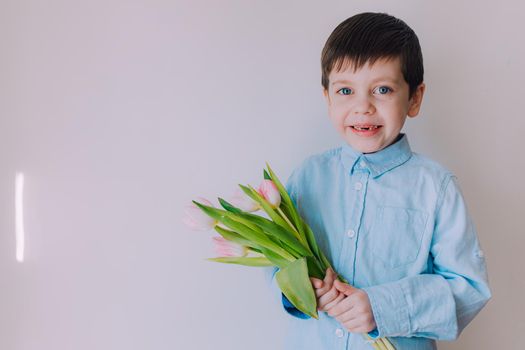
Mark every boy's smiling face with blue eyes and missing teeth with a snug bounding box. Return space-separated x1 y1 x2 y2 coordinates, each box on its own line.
323 58 425 153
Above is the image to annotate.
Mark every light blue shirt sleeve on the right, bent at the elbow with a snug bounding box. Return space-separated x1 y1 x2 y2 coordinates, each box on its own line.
363 175 491 340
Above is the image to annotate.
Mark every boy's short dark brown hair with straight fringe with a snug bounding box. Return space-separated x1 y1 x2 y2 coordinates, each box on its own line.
321 12 424 97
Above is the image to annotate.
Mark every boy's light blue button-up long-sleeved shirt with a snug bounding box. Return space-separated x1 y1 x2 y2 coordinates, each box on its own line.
270 134 491 350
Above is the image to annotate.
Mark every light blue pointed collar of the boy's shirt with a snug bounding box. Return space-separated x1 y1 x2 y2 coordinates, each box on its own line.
341 134 412 178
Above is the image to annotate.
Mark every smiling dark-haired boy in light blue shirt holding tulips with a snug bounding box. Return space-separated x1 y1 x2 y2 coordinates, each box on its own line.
274 13 491 350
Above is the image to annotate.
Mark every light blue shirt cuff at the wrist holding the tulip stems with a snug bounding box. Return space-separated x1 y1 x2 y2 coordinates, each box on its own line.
363 283 410 338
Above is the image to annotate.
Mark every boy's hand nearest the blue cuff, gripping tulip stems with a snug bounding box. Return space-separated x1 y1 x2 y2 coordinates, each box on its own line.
326 280 376 333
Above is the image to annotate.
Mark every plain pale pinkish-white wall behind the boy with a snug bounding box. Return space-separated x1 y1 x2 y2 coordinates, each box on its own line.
0 0 525 350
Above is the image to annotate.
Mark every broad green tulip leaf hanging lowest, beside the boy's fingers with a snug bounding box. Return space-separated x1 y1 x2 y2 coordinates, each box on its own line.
275 258 319 318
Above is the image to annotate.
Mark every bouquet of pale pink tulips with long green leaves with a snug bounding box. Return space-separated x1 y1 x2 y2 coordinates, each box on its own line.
184 164 394 350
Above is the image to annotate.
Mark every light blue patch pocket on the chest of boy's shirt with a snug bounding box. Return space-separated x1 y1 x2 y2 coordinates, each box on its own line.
369 206 428 268
